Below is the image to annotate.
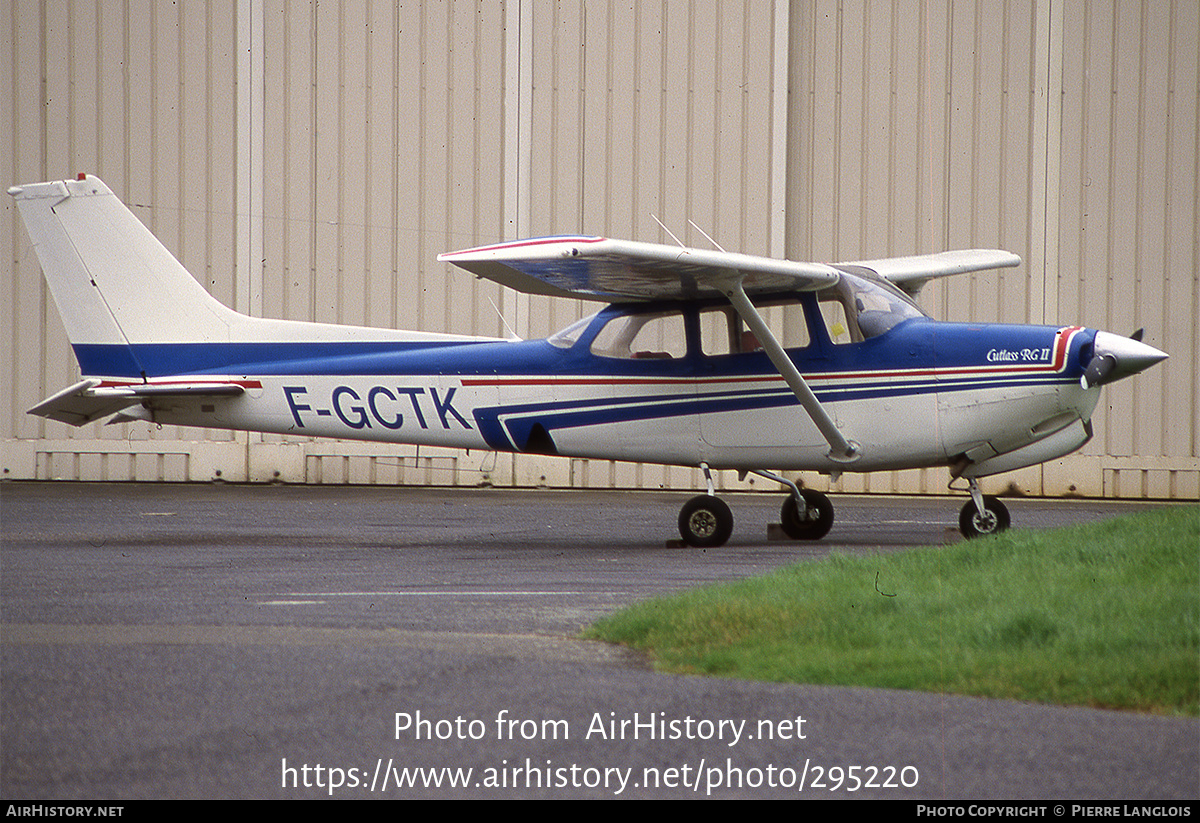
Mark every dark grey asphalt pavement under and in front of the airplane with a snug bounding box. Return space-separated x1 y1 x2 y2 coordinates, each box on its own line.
0 482 1200 800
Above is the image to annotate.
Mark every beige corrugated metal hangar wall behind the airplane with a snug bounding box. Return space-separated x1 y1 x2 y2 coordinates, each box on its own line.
0 0 1200 499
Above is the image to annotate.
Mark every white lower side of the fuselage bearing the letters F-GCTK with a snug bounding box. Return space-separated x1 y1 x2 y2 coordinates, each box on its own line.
129 357 1098 471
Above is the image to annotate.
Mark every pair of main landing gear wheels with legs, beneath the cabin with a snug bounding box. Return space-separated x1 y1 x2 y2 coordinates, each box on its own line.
679 464 833 548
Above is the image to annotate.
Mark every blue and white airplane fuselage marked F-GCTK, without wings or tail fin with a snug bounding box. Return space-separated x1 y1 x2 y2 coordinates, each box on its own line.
77 294 1099 474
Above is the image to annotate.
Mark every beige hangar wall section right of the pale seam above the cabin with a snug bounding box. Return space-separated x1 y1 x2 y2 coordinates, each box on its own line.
787 0 1200 499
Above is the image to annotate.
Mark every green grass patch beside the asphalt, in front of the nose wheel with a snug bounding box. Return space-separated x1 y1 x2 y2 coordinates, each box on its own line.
586 506 1200 715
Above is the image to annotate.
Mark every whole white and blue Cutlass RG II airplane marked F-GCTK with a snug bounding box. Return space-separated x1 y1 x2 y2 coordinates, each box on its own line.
8 175 1166 546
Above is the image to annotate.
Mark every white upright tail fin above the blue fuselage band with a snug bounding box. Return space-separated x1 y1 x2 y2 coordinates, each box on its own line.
8 175 240 352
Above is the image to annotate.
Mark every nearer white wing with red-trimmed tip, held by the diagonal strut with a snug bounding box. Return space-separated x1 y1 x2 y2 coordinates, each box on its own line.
438 236 838 302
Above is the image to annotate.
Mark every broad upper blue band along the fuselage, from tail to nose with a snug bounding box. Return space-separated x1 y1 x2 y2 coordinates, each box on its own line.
74 320 1092 391
